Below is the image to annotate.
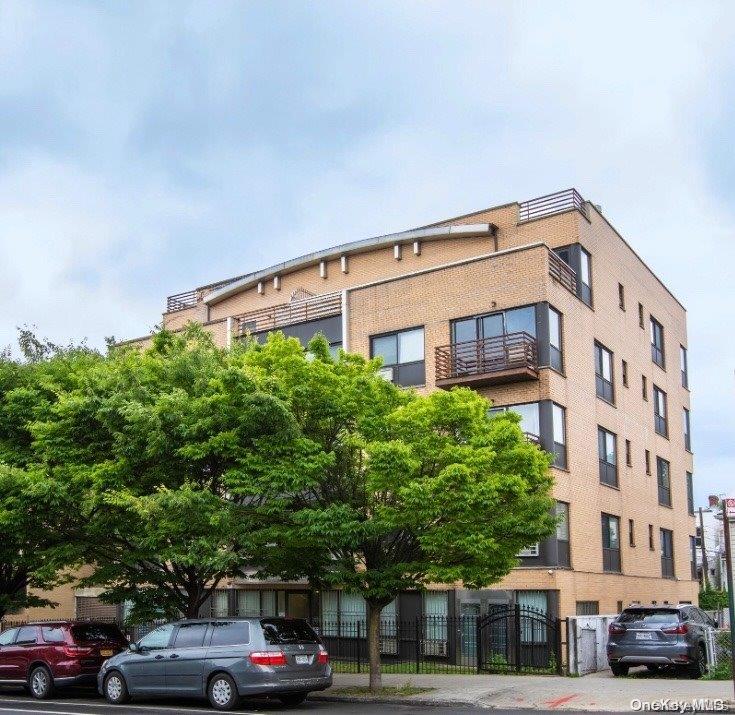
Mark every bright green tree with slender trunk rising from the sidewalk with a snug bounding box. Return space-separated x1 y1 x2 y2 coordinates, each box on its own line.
246 335 555 689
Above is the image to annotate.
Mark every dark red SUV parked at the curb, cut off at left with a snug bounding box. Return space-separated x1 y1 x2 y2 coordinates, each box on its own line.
0 621 128 699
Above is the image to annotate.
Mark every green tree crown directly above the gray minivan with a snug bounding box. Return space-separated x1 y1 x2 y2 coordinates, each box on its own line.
33 326 314 621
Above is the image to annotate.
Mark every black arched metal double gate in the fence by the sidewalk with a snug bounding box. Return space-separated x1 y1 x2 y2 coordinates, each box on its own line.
476 604 562 675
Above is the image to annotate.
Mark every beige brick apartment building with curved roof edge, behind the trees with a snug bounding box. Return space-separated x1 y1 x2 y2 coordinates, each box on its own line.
25 190 697 628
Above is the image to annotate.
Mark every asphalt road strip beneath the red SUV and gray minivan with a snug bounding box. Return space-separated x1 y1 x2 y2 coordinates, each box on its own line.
0 690 632 715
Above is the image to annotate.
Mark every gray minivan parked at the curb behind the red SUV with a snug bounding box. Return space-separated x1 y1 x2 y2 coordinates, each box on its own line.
97 618 332 710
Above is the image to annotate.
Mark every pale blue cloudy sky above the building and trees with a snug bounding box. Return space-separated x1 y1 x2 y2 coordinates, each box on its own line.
0 0 735 503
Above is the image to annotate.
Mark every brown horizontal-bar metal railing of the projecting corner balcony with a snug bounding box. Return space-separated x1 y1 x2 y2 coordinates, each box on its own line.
436 332 538 380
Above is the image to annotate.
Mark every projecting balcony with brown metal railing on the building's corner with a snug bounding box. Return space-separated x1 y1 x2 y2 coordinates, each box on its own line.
436 332 538 388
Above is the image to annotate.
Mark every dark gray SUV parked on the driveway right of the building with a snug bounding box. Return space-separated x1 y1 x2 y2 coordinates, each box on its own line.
607 604 717 678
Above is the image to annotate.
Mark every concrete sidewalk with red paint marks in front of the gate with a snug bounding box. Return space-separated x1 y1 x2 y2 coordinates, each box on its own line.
312 671 733 712
